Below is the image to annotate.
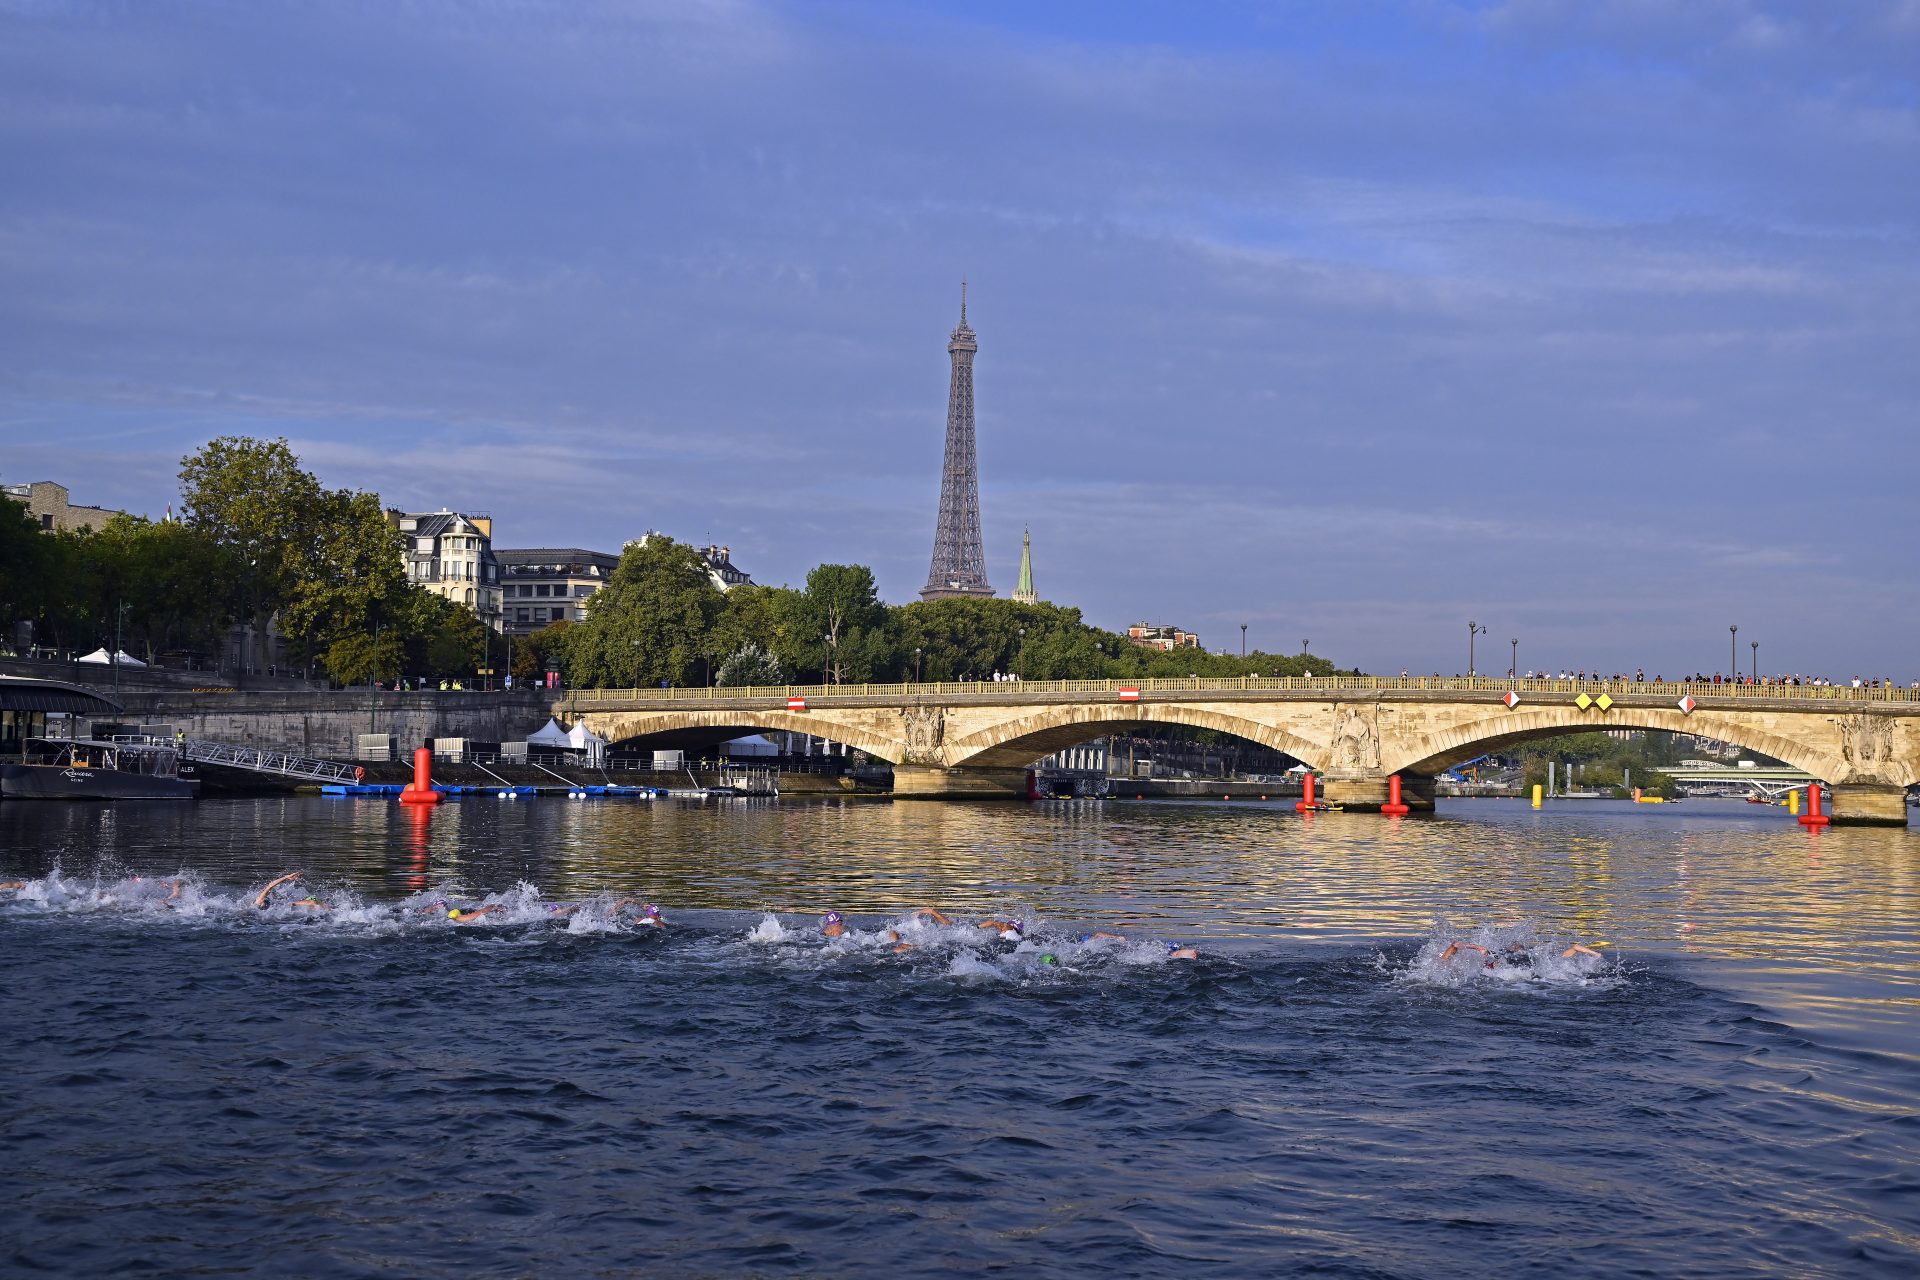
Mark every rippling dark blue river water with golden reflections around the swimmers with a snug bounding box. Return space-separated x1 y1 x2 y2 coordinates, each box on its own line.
0 798 1920 1276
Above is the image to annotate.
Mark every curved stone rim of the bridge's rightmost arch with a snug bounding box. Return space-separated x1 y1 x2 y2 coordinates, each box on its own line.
1380 704 1845 779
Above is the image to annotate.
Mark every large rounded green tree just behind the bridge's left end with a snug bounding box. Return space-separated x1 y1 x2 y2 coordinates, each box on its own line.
566 535 724 687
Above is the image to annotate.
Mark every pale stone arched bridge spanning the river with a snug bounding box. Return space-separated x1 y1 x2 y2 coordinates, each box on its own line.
555 676 1920 825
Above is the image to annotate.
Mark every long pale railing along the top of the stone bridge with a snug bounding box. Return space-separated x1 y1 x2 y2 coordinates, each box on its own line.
568 676 1920 704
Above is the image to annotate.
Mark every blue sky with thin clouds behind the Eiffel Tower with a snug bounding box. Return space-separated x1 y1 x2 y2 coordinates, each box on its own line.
0 0 1920 683
